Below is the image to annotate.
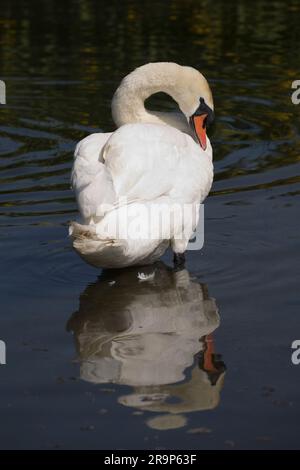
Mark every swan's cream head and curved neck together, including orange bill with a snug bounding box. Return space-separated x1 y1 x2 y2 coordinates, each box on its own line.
112 62 214 150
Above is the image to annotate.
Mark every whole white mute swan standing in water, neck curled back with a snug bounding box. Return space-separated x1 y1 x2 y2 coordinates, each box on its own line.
69 62 213 268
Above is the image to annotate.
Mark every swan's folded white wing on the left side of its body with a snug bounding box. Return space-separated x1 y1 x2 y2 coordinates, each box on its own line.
71 133 116 223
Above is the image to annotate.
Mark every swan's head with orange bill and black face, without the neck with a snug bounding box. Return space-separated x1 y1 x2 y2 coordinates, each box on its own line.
173 66 214 150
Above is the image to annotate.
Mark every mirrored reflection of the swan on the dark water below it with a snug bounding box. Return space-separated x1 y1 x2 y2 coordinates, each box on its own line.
67 263 225 429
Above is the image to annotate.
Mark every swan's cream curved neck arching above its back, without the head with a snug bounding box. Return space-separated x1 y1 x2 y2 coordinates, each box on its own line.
112 64 188 128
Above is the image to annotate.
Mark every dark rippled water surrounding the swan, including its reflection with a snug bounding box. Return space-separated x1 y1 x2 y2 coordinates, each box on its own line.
0 0 300 449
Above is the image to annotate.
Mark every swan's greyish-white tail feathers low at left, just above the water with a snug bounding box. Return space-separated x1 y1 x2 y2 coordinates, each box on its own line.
69 222 128 268
